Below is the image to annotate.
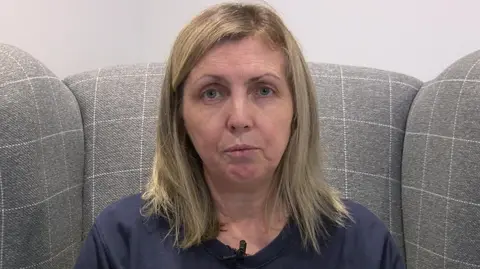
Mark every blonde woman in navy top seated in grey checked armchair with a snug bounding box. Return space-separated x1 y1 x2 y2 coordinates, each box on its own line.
76 4 404 269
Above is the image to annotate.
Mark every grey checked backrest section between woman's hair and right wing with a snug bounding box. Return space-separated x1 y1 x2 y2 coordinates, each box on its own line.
310 61 422 256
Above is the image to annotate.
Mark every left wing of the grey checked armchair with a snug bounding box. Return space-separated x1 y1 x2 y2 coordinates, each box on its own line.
0 44 84 268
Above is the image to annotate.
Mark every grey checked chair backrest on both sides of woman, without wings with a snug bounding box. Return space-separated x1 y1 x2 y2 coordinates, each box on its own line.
65 59 422 260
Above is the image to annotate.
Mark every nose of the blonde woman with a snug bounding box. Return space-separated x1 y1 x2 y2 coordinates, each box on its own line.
227 94 253 133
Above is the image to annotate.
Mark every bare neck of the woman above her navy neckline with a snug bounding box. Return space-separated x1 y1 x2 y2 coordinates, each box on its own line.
205 169 287 254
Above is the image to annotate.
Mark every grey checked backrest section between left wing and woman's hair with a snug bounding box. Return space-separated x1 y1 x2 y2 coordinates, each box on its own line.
64 63 163 236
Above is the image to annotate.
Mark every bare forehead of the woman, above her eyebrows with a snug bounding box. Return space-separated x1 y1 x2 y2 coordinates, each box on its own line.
189 37 285 79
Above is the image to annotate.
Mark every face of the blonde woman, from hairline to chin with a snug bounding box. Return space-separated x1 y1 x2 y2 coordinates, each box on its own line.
182 37 293 184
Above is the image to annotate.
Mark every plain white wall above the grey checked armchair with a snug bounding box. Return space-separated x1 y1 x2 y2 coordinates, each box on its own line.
0 0 480 80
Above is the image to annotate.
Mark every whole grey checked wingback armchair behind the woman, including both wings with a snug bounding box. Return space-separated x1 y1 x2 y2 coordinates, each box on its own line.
0 42 480 268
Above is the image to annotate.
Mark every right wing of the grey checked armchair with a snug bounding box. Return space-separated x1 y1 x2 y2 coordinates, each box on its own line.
402 51 480 268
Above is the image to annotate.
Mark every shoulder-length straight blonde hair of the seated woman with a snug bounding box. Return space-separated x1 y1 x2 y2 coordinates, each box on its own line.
143 3 348 251
